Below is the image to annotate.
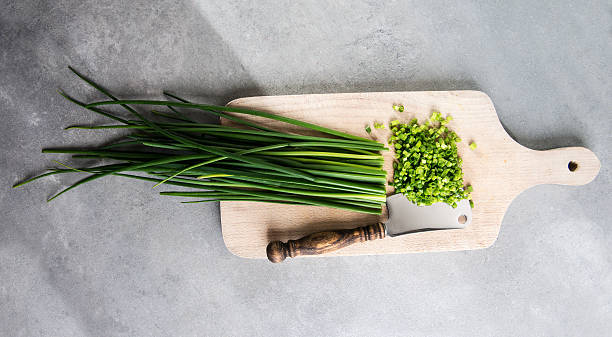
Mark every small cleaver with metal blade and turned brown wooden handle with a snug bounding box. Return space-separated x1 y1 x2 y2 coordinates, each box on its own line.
266 193 472 263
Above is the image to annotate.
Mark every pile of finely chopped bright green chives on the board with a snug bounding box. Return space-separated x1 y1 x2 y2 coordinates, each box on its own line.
389 107 472 207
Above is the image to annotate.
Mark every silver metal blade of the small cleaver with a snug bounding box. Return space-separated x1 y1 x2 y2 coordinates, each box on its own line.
385 193 472 236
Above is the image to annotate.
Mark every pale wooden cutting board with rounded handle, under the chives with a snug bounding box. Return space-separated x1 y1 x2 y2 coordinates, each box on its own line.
221 91 600 258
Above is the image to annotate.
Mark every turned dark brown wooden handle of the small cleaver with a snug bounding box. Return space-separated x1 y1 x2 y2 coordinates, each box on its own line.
266 222 385 263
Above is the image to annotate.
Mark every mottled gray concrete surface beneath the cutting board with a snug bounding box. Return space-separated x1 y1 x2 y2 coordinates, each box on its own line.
0 0 612 336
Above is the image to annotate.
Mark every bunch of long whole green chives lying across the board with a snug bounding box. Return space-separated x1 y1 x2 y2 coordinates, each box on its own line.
14 68 386 214
